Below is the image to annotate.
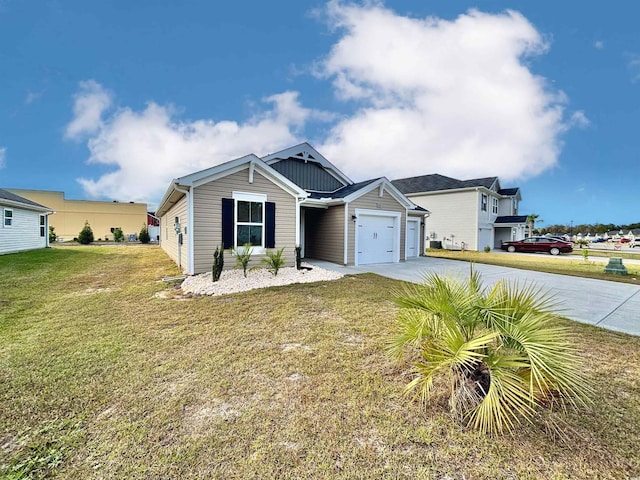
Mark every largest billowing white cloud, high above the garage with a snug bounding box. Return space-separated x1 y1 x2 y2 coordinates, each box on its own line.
317 1 572 181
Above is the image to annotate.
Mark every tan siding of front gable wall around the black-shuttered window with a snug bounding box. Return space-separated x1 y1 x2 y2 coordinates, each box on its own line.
193 167 296 274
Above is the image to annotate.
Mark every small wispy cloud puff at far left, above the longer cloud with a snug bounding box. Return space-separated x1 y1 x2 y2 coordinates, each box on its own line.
65 80 112 140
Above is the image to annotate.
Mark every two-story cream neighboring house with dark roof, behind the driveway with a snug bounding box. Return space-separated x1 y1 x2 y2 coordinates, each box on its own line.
391 174 529 251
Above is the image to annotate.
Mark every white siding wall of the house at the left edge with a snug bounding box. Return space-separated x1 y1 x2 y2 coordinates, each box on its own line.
0 205 49 254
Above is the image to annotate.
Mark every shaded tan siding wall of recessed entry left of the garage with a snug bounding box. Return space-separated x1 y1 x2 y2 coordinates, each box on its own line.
304 205 344 265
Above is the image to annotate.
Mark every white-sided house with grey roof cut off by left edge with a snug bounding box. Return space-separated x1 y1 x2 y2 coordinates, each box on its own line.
0 188 54 254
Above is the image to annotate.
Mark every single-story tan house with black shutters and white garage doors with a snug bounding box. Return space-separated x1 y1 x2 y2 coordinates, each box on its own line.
156 143 429 274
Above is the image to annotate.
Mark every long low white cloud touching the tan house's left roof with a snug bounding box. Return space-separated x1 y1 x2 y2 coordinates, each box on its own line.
78 92 322 203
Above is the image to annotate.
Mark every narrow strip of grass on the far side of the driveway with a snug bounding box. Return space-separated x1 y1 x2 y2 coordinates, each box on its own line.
427 249 640 285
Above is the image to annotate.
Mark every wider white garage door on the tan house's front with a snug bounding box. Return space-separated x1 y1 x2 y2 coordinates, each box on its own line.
356 214 397 265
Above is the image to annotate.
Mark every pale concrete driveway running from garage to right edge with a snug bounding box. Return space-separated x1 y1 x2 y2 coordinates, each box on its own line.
308 257 640 335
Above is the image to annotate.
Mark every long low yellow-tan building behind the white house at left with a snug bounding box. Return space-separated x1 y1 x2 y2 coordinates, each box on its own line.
8 188 147 241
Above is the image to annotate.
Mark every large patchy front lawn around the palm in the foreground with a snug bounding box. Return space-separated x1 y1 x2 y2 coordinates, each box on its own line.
0 246 640 479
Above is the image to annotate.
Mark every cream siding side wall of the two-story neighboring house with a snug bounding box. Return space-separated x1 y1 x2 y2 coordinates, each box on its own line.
407 190 480 250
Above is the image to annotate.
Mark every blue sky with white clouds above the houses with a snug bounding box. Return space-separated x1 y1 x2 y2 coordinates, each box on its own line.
0 0 640 226
